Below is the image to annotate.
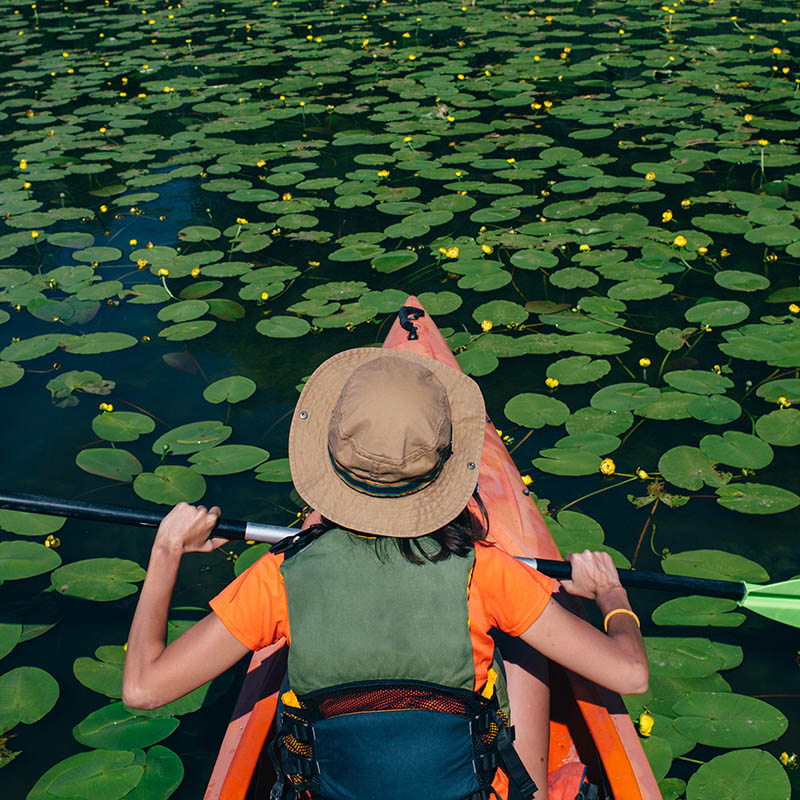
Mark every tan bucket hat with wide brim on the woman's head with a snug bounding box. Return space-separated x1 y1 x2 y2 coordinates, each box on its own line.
289 348 486 538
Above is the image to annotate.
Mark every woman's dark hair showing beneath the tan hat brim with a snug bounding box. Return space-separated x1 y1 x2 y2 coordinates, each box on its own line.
298 488 489 564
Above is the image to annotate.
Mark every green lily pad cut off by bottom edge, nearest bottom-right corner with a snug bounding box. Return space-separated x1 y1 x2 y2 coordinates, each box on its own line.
686 750 792 800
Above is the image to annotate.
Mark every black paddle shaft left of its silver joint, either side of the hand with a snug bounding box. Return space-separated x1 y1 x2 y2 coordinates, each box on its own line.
0 492 247 539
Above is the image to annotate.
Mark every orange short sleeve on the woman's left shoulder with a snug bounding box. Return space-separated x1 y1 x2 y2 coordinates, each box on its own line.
209 554 289 650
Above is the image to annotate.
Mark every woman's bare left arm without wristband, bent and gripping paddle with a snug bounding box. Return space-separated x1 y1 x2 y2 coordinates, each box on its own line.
122 503 250 708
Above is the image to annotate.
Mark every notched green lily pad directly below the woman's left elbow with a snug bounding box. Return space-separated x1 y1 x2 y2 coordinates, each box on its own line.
72 703 180 750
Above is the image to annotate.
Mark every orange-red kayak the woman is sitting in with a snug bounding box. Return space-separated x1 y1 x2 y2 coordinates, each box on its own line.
205 296 661 800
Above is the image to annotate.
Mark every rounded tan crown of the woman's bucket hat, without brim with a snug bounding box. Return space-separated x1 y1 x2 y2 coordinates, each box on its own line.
328 357 451 484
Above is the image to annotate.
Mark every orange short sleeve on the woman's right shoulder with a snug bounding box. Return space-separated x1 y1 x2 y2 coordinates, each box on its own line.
472 545 558 636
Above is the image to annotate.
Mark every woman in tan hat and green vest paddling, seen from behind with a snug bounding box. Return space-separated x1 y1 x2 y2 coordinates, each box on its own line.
123 348 648 800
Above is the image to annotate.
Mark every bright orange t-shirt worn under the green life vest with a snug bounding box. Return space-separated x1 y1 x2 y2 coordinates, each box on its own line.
211 543 557 691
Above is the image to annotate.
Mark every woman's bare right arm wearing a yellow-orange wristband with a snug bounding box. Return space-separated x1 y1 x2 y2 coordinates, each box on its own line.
522 550 649 694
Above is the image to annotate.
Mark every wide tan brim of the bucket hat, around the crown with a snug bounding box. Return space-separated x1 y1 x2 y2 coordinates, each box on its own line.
289 347 486 538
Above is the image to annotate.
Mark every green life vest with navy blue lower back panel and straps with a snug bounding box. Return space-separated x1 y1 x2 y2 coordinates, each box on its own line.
272 529 535 800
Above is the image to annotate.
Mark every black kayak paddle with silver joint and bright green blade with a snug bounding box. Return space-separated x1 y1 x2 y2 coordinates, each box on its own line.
0 492 800 628
